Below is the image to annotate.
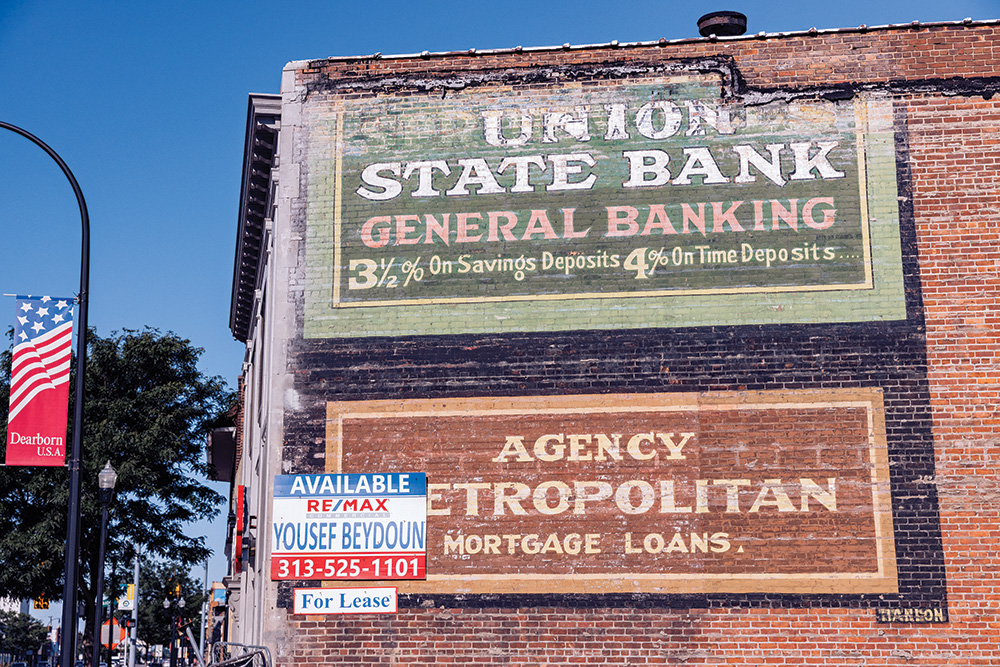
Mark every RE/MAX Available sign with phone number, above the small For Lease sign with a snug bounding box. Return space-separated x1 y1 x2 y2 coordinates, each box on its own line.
271 472 427 579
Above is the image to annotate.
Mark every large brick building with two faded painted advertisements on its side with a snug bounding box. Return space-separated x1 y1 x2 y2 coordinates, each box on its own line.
227 21 1000 666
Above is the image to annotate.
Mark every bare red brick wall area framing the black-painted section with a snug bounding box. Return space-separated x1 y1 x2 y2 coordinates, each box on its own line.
278 26 1000 667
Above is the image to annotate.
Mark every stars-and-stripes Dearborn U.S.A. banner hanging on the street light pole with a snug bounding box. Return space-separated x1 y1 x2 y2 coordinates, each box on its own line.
6 296 73 466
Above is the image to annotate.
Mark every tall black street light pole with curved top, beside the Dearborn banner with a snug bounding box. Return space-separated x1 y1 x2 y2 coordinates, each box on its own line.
0 121 90 667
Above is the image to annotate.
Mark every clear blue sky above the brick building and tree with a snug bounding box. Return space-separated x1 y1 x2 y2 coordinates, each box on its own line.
0 0 1000 616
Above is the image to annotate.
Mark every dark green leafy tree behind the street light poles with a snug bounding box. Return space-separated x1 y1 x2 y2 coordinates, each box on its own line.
0 328 233 634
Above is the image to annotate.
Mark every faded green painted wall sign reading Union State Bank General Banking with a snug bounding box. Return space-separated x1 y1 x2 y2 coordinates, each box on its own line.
303 75 905 337
